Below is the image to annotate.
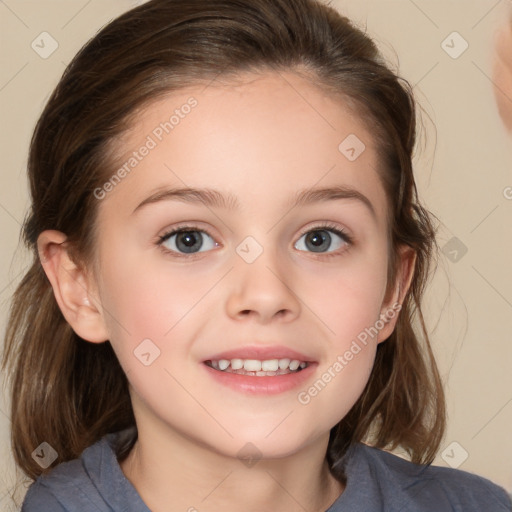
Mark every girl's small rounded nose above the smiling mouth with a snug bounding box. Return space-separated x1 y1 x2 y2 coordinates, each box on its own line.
226 247 301 324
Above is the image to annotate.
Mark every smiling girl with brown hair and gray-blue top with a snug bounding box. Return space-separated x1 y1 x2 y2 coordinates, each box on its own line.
3 0 511 512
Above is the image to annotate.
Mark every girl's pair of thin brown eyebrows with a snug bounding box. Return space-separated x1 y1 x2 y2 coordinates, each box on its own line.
132 185 377 220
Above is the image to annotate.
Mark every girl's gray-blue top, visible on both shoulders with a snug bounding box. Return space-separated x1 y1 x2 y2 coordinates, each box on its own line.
21 429 512 512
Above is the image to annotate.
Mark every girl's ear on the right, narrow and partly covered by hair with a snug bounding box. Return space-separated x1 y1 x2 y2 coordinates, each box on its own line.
377 245 416 343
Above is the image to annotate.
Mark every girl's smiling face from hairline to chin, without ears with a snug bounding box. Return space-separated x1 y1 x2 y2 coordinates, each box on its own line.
90 73 398 457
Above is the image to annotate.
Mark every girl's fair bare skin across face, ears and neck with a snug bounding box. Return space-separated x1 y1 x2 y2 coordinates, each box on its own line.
38 72 414 512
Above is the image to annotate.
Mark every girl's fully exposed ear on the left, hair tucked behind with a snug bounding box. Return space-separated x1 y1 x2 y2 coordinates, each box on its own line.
37 230 109 343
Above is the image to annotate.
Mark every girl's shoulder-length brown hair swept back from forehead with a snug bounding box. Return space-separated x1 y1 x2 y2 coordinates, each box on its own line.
2 0 445 488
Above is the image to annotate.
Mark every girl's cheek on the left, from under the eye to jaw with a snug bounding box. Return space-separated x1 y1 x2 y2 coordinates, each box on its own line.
97 260 214 418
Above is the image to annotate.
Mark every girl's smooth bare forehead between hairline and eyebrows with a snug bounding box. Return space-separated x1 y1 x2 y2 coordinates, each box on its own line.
101 72 385 220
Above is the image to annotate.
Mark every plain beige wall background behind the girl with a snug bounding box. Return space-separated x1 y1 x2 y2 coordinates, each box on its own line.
0 0 512 511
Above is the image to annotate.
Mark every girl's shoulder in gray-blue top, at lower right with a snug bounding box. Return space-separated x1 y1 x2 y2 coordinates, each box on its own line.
350 445 512 512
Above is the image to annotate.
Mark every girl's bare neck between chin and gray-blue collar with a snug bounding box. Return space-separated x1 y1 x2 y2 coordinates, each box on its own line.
120 427 343 512
